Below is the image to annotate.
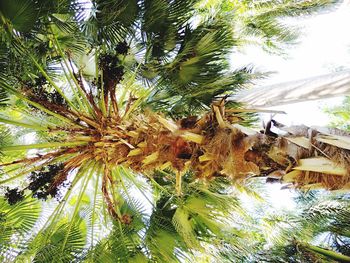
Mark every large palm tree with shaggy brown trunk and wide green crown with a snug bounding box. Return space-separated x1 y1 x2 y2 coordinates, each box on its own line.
0 0 349 262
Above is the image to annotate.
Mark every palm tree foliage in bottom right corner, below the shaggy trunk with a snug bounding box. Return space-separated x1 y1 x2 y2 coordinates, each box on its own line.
252 191 350 262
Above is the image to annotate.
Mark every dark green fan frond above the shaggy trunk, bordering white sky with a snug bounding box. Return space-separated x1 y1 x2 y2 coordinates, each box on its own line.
148 21 250 116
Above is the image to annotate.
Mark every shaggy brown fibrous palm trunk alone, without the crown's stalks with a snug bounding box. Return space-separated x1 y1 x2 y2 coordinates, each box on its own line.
117 106 350 194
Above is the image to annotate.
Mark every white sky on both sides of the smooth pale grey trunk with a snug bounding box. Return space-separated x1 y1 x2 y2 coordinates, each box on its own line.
232 0 350 126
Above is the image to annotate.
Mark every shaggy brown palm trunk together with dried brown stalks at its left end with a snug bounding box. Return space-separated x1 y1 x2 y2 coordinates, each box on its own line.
3 103 350 220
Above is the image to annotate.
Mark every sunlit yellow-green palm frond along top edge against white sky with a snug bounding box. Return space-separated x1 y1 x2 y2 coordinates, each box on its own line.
198 0 339 53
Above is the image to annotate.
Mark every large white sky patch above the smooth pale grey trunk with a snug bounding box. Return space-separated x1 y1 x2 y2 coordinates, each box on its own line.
231 2 350 85
